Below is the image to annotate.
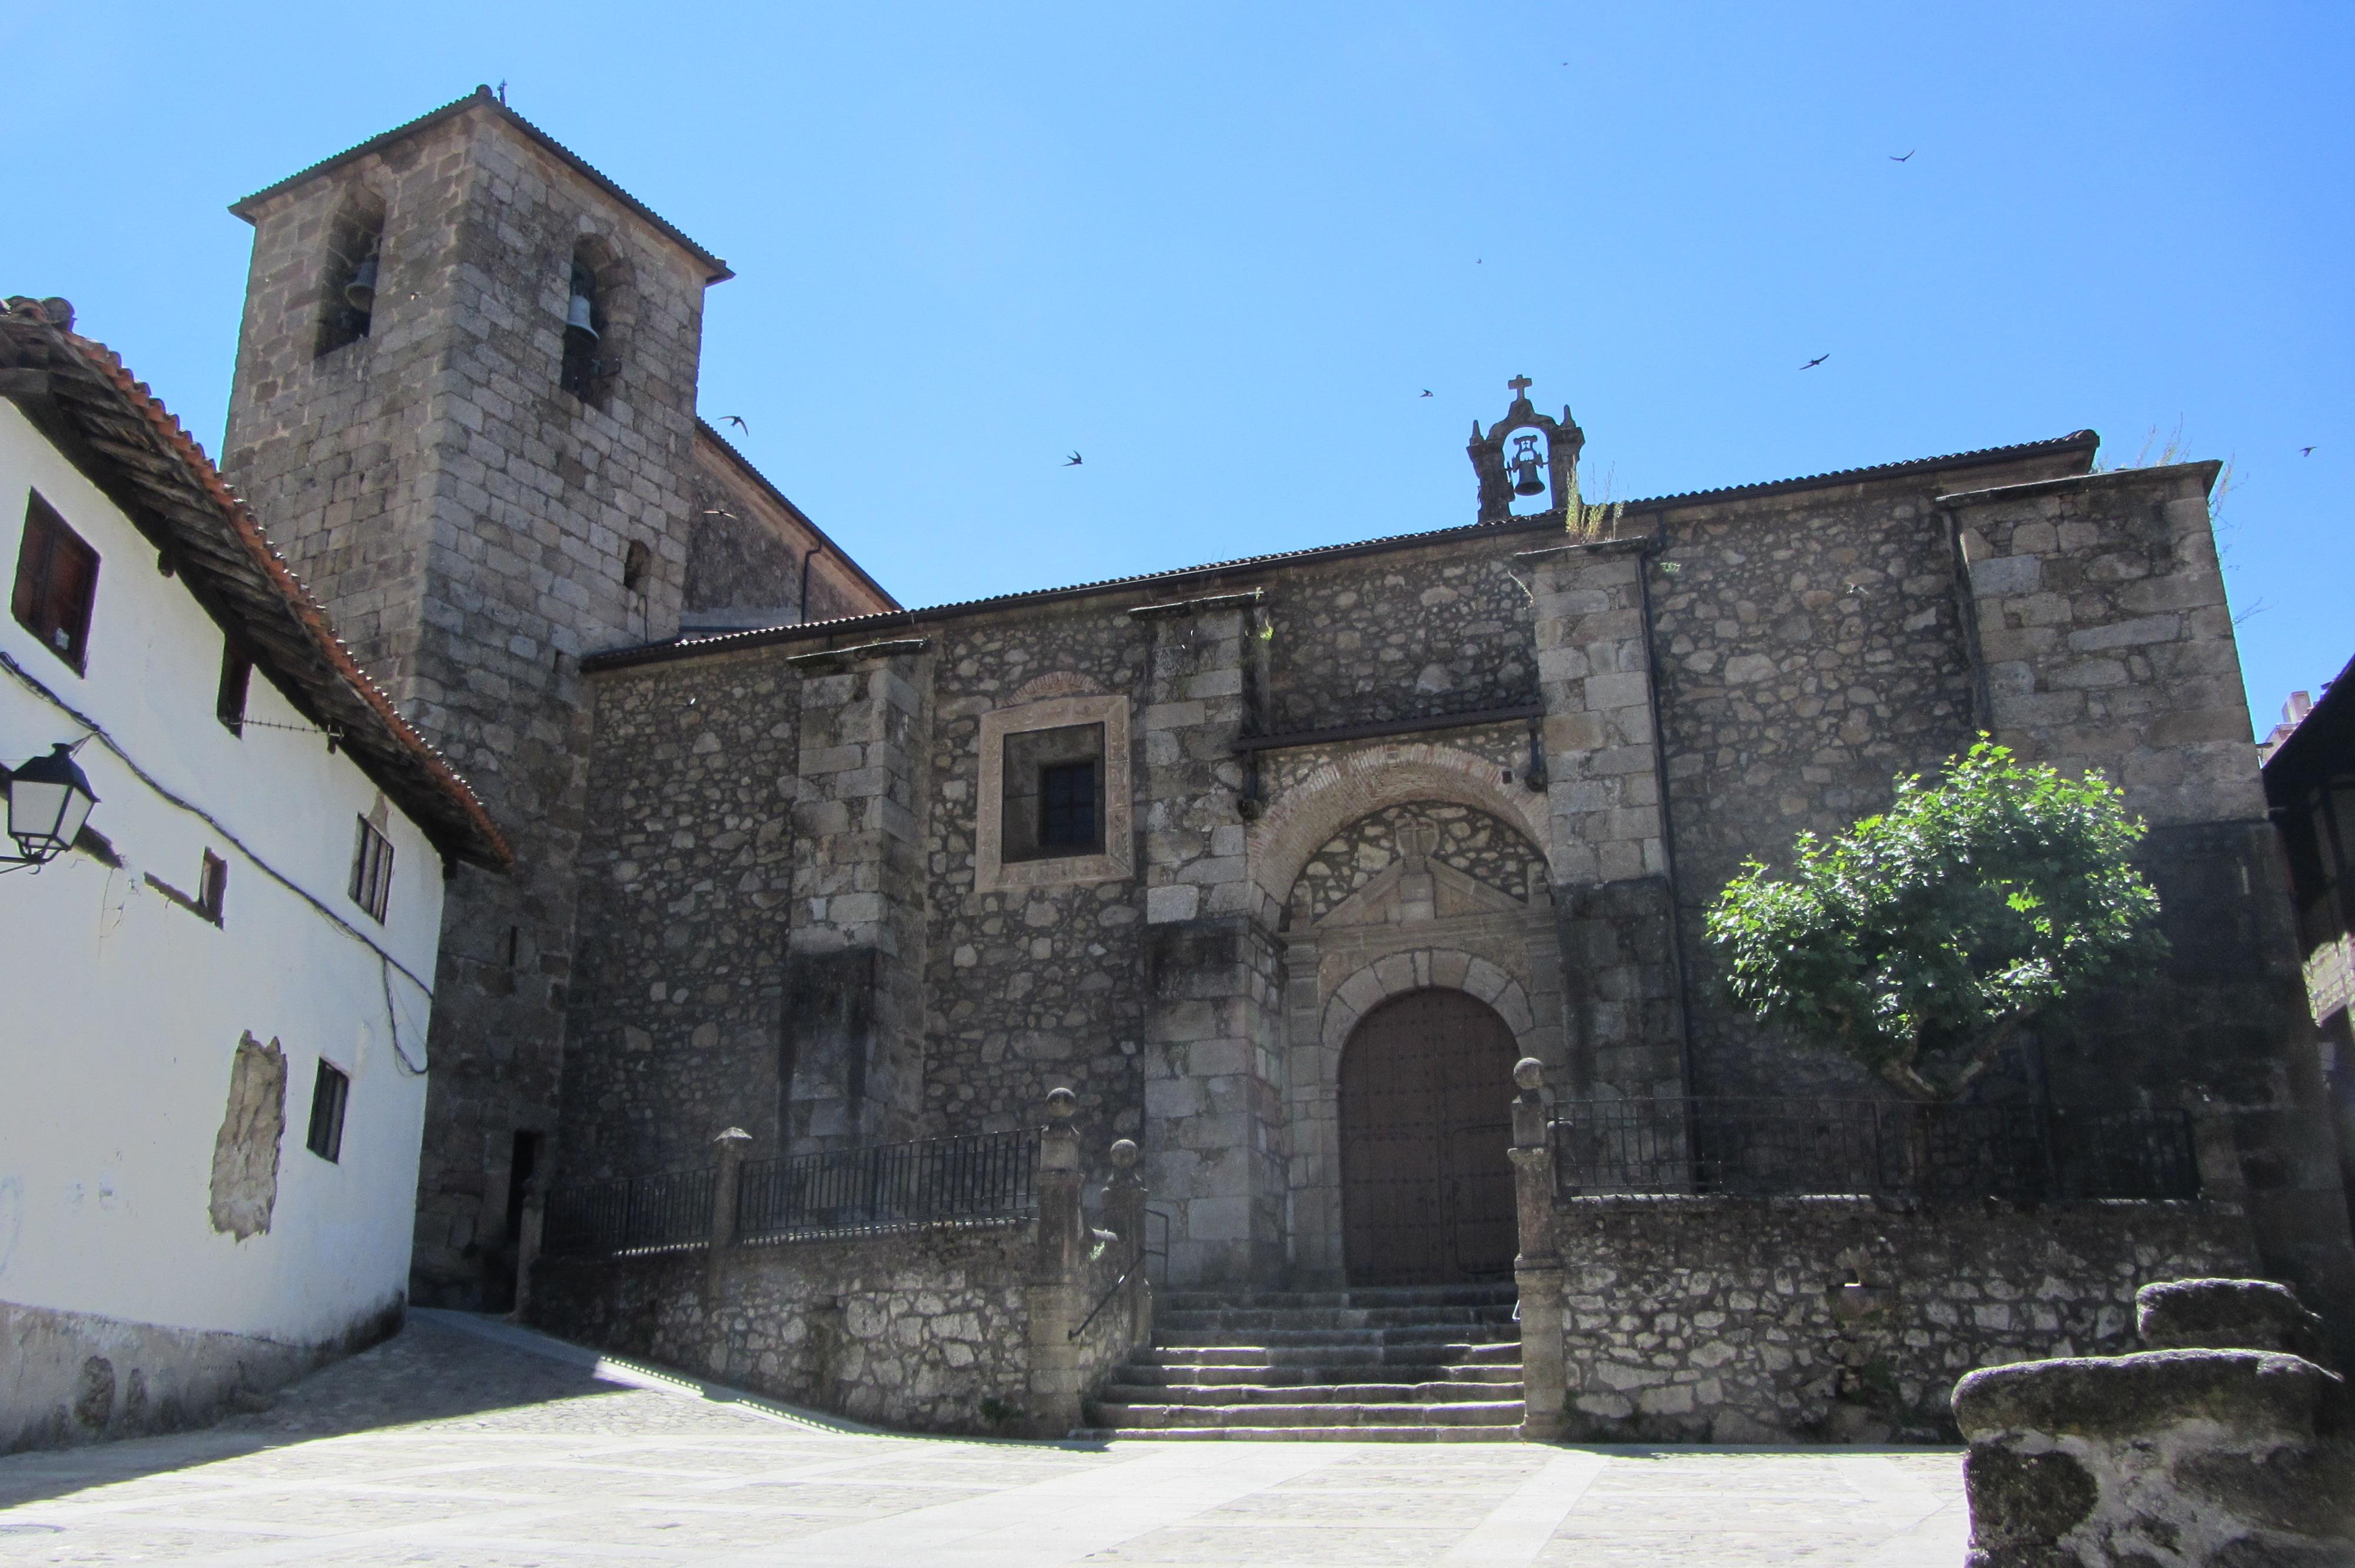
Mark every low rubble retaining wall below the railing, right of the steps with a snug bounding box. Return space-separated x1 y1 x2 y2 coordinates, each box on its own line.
1557 1198 2251 1443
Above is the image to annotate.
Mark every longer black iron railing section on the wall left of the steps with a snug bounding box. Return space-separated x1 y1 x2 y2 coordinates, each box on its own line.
737 1130 1039 1241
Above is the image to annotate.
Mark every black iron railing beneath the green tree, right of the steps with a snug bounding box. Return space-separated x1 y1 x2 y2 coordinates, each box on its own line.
1554 1097 2200 1201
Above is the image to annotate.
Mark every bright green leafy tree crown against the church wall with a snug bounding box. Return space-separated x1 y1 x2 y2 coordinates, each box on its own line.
1707 737 2167 1099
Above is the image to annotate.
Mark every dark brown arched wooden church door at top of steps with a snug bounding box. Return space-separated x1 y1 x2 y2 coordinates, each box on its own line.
1340 989 1517 1285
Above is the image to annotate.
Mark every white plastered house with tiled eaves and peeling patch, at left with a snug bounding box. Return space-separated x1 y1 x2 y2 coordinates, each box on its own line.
0 301 506 1453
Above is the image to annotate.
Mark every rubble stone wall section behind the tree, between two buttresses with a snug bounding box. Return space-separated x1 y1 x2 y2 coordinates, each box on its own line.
1651 485 1973 1095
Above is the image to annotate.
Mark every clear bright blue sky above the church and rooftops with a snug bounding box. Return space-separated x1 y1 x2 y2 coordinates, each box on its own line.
0 0 2355 727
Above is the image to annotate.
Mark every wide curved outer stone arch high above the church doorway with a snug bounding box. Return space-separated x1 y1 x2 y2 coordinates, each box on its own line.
1248 742 1552 909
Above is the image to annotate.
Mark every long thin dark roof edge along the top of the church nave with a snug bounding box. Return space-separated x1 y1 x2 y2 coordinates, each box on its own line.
582 431 2101 671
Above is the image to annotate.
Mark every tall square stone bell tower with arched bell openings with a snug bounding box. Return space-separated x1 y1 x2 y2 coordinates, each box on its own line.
224 87 730 1307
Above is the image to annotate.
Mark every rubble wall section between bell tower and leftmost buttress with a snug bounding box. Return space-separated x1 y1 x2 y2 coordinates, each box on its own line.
558 657 803 1180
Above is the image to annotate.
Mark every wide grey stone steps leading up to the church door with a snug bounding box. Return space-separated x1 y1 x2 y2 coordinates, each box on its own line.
1074 1285 1521 1443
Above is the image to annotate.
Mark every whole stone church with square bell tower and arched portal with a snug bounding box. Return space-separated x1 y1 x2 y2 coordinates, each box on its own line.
212 94 2355 1304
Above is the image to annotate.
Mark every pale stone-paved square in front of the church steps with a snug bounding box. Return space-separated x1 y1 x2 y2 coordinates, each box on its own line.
0 1311 1966 1568
